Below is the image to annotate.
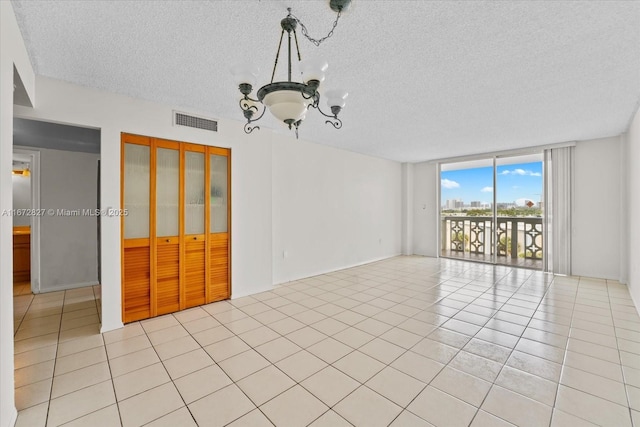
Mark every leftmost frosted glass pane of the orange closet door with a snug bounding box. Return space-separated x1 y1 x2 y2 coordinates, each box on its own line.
124 143 150 239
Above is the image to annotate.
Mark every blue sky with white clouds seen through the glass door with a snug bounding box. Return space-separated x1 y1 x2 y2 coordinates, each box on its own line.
440 162 542 205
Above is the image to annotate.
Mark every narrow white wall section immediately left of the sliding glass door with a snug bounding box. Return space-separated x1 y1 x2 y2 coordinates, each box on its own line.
413 162 440 257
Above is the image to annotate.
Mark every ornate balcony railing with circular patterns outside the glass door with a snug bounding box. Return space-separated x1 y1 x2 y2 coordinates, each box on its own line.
441 216 543 268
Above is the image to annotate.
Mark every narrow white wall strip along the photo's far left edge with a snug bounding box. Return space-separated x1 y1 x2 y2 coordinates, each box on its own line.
0 1 35 427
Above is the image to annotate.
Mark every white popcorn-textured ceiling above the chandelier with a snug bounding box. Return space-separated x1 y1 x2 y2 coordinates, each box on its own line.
12 0 640 161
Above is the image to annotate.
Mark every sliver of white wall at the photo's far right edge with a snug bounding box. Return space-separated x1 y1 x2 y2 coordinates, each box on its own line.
624 110 640 312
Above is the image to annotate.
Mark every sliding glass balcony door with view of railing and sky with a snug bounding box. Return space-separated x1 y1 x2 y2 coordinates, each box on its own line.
440 153 544 269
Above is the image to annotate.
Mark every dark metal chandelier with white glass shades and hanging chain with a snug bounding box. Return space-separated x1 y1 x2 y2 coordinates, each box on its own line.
231 0 351 138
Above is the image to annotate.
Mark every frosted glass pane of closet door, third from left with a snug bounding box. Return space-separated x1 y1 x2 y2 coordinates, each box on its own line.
184 151 204 234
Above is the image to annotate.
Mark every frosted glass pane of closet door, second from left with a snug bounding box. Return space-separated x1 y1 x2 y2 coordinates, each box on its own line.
156 148 180 237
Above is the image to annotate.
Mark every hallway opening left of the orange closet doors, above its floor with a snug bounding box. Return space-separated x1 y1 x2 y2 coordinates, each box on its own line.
13 118 100 295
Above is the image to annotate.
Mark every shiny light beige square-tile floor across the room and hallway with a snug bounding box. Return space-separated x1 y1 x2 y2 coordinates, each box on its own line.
15 257 640 427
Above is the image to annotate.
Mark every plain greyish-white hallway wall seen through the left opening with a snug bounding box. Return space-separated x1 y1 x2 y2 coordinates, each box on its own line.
33 148 100 292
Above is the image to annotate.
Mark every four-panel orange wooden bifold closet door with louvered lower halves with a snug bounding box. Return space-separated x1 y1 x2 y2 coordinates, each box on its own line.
121 134 231 323
